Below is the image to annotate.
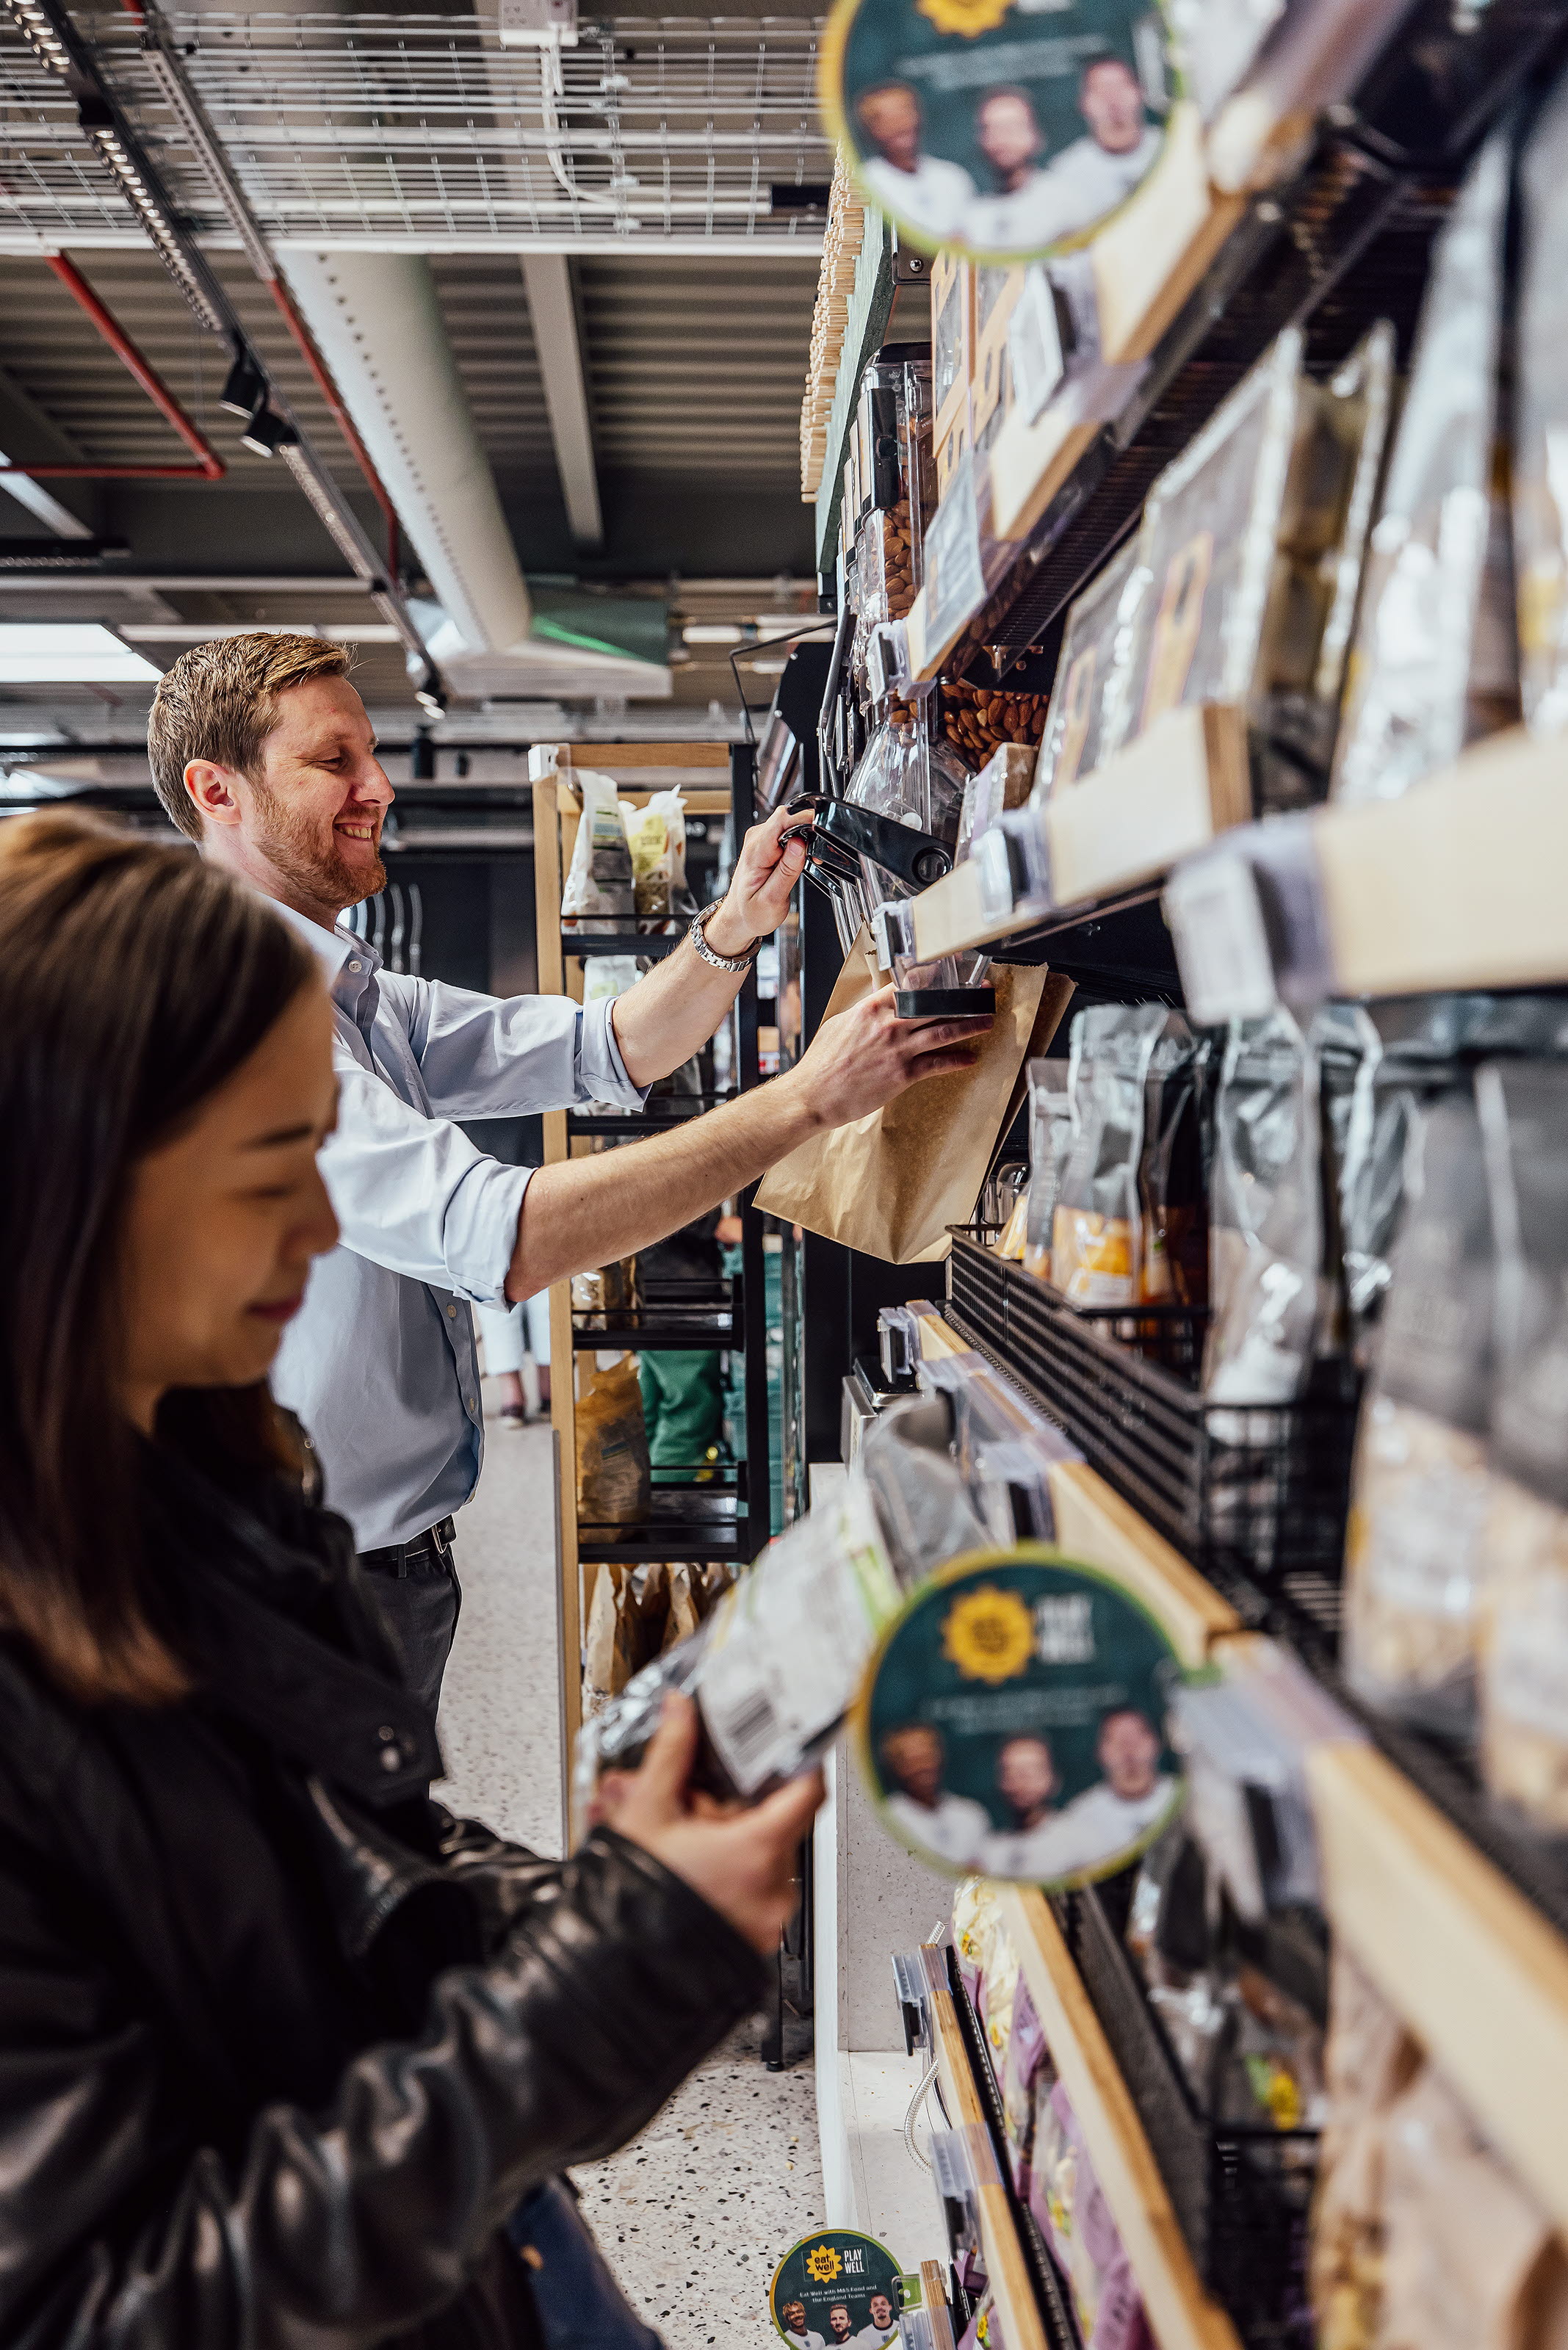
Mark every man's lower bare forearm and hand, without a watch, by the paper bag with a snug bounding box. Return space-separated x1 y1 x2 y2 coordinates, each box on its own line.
505 982 990 1300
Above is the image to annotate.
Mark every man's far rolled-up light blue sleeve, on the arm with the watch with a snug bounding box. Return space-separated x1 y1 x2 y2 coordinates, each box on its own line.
390 973 646 1118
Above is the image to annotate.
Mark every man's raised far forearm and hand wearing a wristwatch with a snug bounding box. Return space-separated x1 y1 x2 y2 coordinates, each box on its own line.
611 789 806 1085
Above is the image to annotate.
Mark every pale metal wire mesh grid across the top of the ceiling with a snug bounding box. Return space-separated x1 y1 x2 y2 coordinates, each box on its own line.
0 12 830 254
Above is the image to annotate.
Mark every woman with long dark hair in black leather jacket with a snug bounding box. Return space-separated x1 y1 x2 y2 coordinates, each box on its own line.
0 815 820 2350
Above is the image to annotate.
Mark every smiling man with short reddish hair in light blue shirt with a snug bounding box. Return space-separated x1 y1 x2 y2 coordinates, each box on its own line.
148 634 985 1708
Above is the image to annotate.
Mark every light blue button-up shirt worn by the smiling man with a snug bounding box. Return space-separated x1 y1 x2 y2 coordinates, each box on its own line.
272 905 644 1551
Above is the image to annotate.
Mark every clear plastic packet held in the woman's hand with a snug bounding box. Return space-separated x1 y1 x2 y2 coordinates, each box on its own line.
574 1396 985 1833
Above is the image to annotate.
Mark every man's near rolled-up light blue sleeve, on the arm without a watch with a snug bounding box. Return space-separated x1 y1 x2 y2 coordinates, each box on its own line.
322 1044 534 1306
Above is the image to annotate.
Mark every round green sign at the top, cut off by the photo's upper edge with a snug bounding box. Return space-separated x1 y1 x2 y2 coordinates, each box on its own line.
820 0 1173 261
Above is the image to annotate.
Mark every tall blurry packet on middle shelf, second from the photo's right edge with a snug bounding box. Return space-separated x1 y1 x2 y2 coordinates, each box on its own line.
1345 1095 1495 1737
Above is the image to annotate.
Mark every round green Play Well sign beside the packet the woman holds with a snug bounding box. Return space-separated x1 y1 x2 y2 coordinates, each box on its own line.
856 1544 1185 1884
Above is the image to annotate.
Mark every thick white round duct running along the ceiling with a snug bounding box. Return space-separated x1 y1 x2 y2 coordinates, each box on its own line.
280 251 670 698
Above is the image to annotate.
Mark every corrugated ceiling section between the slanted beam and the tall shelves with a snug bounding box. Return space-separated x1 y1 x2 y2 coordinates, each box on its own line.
576 256 816 484
